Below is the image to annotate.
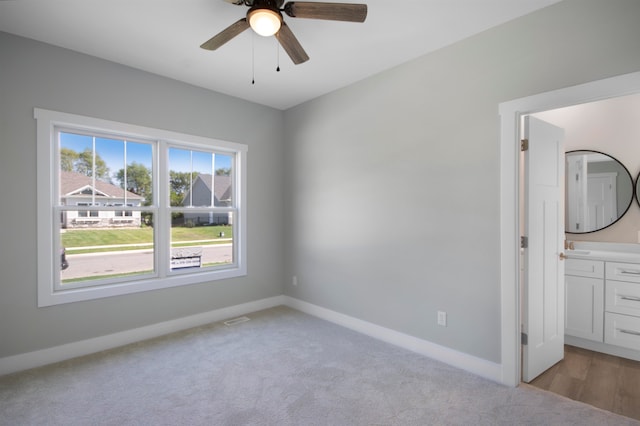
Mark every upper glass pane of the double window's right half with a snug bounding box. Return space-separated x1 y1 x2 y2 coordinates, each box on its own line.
169 148 233 207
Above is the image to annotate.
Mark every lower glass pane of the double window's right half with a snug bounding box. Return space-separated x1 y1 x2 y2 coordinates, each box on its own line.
171 218 233 270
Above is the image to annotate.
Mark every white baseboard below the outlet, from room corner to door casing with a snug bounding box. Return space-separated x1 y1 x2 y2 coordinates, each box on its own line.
284 296 502 383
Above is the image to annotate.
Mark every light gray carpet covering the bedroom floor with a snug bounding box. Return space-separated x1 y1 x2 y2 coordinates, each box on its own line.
0 307 640 426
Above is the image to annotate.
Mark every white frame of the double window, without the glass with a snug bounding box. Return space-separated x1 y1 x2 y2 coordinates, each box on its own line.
34 108 248 307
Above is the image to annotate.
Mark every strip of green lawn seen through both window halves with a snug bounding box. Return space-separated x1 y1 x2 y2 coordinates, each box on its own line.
60 226 233 253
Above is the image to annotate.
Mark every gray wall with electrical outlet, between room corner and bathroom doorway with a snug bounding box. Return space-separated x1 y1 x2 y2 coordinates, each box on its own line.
285 0 640 362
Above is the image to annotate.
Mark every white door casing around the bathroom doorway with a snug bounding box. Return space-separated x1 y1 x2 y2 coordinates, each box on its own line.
498 72 640 386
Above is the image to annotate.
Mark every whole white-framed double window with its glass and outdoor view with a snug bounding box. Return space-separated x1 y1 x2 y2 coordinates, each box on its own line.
35 109 247 306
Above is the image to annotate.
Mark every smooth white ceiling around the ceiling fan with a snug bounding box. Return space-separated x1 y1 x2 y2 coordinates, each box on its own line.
0 0 559 110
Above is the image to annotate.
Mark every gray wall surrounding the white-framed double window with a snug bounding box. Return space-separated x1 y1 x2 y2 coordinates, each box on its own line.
0 33 284 357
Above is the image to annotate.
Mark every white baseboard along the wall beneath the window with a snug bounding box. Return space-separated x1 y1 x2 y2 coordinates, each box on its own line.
0 296 285 376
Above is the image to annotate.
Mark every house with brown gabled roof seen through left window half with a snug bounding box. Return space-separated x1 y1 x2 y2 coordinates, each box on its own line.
60 172 144 228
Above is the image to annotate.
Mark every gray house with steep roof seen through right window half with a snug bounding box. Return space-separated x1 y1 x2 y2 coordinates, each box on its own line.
182 174 232 225
